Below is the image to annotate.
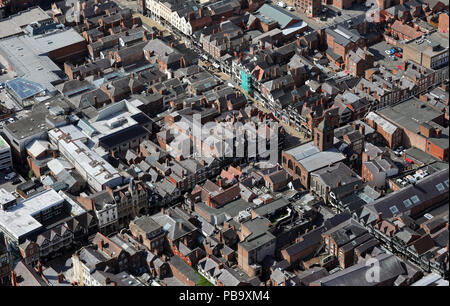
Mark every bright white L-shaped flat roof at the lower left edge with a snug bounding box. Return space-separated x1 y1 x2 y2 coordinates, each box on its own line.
0 189 64 240
